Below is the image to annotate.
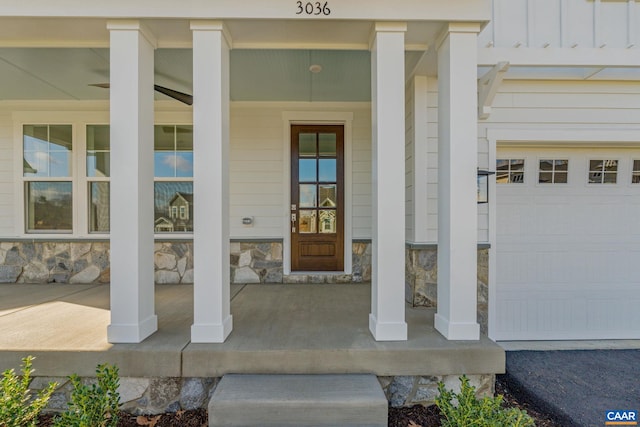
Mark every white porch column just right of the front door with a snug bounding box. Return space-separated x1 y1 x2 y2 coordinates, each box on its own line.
369 22 407 341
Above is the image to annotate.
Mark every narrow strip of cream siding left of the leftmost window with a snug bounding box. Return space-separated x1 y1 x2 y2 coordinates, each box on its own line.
0 111 15 236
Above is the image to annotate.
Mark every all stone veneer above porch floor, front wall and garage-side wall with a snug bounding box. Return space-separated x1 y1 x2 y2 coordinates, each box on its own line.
0 240 489 333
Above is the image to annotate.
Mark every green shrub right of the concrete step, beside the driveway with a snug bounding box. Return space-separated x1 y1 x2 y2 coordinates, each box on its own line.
436 375 535 427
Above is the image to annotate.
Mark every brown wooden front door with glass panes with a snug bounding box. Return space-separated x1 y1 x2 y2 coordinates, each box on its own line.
291 125 344 271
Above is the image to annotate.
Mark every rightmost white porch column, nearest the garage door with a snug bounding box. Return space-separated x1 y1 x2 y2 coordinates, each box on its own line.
435 23 480 340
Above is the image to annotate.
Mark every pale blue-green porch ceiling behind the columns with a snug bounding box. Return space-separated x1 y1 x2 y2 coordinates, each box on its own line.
0 48 430 102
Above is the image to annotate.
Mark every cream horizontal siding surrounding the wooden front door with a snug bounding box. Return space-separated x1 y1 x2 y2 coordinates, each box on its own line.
230 102 371 239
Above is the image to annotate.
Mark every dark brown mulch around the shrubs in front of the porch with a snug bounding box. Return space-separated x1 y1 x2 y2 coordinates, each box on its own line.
38 376 562 427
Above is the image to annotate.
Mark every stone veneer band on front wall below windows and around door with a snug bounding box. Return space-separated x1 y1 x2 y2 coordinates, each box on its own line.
0 240 371 284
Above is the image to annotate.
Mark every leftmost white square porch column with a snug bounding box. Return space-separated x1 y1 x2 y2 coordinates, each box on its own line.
107 21 158 343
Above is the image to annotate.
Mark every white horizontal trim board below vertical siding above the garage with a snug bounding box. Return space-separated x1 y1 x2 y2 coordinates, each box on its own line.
478 47 640 67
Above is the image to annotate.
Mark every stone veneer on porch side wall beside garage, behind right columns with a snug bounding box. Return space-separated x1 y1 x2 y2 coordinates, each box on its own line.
405 245 489 334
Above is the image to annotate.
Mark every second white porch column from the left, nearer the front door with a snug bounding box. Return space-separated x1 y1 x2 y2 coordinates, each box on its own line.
191 21 232 343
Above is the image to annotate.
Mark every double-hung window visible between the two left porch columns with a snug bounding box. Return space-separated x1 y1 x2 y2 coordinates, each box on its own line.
154 125 193 233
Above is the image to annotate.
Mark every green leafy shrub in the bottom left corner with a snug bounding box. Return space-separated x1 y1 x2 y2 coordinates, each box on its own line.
0 356 58 427
